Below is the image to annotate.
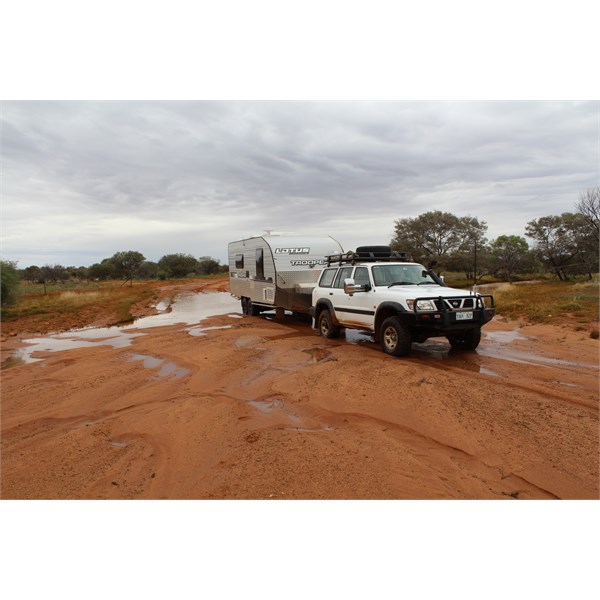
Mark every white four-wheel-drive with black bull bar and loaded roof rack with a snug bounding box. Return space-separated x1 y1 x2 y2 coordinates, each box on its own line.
311 246 495 356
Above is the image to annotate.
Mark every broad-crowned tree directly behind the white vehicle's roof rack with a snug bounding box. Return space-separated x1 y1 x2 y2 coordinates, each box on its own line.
390 210 487 269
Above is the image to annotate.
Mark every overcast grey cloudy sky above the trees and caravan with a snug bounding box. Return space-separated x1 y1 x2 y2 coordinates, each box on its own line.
2 101 599 267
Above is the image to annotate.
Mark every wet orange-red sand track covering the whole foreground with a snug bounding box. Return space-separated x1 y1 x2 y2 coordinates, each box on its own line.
0 286 599 500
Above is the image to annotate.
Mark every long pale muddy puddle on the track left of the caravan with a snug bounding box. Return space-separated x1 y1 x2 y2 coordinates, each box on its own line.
3 292 241 370
